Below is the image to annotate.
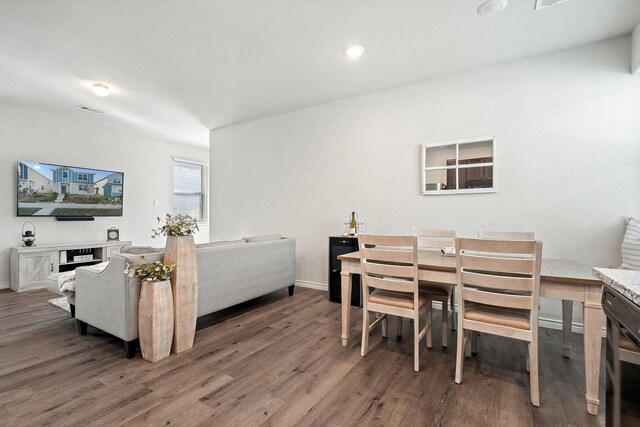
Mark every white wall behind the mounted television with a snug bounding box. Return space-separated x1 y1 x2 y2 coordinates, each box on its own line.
0 104 209 287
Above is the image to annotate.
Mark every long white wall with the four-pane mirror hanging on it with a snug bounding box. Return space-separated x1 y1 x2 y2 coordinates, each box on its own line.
210 37 640 332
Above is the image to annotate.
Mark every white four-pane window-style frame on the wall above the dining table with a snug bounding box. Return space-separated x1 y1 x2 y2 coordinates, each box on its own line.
420 136 496 196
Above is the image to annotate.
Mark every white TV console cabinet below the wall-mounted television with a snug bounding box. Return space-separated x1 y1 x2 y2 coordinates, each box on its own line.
11 242 131 292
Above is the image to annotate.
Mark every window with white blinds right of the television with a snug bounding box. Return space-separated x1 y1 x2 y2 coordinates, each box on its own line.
173 160 207 221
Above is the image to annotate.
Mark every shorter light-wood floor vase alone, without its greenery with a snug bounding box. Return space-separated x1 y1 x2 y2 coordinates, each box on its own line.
138 280 173 362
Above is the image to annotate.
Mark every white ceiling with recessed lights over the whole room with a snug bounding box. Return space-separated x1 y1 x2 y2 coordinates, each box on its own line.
0 0 640 146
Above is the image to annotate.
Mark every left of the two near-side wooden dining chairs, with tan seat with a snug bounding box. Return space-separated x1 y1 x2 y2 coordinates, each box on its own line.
358 233 431 372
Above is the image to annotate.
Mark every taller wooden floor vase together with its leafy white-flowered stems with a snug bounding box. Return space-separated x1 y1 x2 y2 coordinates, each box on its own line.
152 214 198 353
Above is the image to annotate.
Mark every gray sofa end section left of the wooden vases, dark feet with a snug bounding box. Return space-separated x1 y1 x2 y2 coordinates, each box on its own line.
75 249 164 359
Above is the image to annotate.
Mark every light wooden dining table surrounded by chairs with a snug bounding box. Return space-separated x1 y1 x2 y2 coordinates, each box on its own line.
338 250 604 415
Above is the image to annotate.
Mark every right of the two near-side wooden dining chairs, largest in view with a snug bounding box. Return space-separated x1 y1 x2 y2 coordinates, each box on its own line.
455 238 542 406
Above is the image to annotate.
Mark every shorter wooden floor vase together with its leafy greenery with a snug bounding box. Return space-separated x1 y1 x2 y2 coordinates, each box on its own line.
125 256 176 362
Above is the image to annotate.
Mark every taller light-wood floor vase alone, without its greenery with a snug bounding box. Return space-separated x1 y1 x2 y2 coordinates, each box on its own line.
164 236 198 353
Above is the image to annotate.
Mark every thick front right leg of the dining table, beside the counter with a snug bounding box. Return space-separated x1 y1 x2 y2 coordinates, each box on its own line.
582 287 604 415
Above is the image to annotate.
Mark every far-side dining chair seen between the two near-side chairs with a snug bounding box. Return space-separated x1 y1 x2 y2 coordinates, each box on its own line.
412 227 458 348
